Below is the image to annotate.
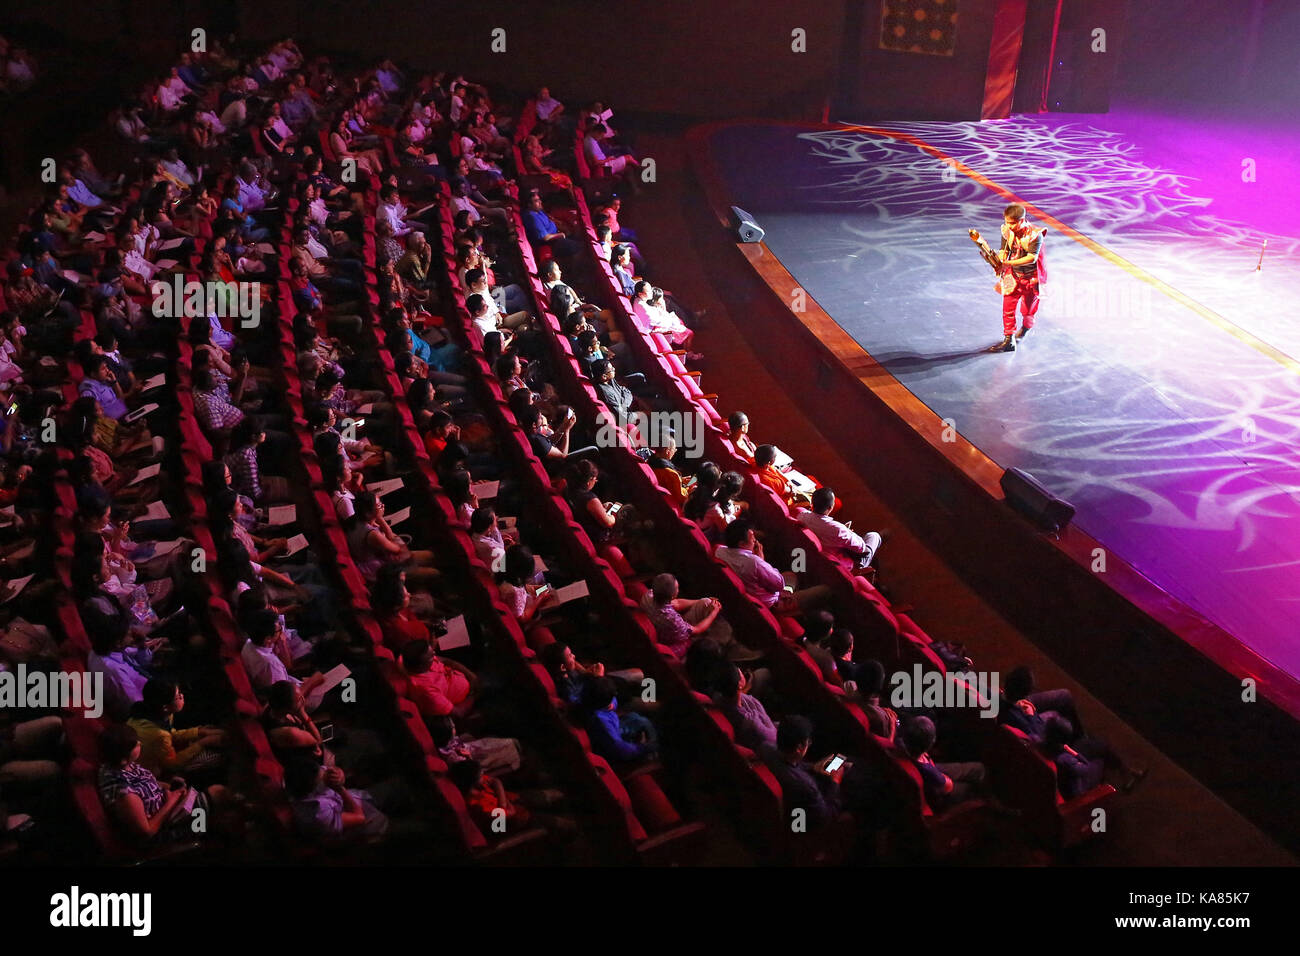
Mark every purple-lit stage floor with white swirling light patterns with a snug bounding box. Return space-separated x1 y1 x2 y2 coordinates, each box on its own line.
711 108 1300 676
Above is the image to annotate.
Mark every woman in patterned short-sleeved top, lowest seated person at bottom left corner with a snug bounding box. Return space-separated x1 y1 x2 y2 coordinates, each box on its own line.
99 724 230 843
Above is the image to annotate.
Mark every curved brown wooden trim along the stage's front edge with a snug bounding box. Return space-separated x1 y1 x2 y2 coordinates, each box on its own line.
686 120 1300 721
